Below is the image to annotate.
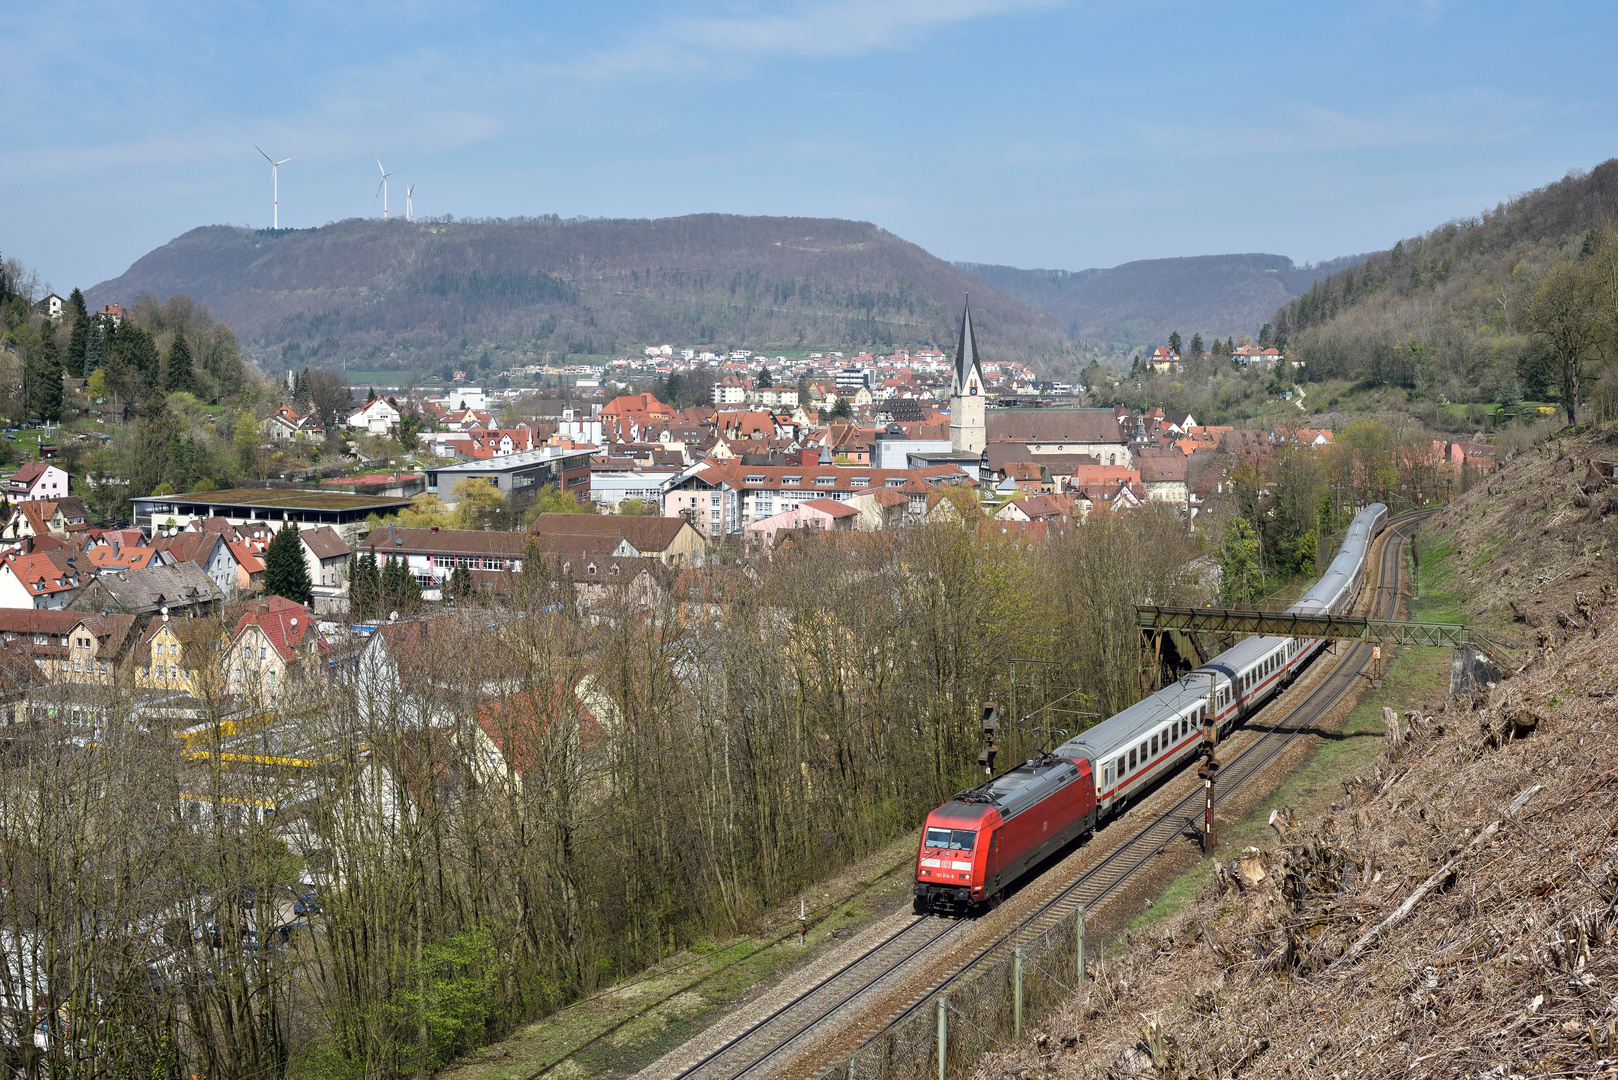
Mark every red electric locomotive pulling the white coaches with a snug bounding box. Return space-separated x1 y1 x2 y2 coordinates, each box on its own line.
916 755 1095 915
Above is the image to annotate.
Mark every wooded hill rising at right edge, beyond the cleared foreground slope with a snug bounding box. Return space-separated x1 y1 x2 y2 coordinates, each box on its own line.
1272 160 1618 405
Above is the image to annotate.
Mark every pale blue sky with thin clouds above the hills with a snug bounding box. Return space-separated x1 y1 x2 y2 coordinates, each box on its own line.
0 0 1618 293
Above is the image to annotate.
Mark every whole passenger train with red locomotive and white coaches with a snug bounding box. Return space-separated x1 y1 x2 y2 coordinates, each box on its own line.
914 502 1388 915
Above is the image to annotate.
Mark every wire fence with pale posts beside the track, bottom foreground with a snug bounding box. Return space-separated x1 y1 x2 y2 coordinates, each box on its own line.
817 907 1097 1080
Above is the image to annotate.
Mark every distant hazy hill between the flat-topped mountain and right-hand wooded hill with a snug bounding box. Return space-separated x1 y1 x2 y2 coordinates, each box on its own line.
956 254 1364 353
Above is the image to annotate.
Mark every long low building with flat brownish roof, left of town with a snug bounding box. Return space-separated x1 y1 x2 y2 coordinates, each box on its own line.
129 487 411 547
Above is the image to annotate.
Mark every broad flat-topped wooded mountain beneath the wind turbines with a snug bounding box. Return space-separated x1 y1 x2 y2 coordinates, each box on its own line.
87 214 1066 372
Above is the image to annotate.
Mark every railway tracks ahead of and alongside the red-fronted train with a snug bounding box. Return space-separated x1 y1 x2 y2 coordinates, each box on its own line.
646 510 1432 1080
